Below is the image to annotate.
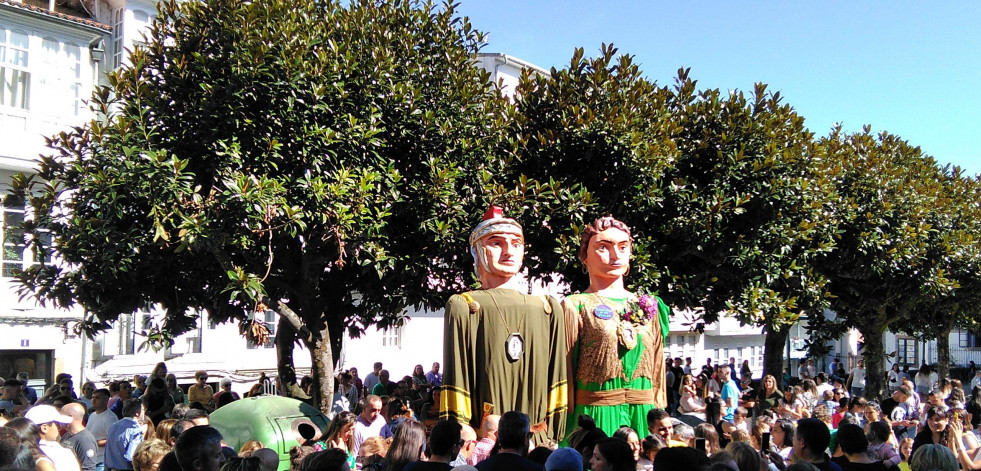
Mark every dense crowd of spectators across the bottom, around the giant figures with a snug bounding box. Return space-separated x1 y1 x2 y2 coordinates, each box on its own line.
0 358 981 471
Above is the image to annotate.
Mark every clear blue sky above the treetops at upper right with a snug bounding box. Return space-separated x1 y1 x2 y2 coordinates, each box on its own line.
459 0 981 174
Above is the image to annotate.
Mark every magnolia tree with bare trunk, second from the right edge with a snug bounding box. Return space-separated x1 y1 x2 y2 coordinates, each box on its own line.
811 127 953 398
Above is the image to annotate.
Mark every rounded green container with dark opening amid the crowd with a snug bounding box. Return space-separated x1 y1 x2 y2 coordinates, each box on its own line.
211 396 330 471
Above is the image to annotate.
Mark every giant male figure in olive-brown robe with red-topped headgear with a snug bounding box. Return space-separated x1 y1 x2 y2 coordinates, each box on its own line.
440 206 568 443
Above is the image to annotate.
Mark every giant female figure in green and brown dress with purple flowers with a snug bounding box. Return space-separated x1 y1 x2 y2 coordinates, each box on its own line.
563 217 670 435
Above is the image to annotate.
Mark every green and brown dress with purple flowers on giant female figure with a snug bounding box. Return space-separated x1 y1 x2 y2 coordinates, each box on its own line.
563 293 670 436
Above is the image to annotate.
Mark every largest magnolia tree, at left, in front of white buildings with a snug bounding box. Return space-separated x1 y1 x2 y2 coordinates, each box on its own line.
18 0 576 409
